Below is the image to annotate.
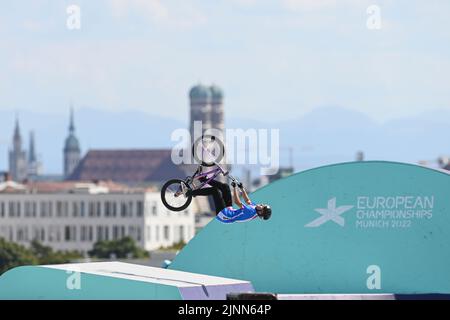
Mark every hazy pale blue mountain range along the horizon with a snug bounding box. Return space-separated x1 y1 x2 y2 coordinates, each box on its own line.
0 107 450 173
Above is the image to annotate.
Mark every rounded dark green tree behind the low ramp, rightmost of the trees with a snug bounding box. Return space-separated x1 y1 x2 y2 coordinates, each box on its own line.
89 237 148 259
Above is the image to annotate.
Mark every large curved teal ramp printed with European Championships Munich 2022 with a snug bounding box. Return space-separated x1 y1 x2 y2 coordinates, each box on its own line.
170 161 450 294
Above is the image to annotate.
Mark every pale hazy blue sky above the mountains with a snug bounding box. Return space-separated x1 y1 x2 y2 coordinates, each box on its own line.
0 0 450 121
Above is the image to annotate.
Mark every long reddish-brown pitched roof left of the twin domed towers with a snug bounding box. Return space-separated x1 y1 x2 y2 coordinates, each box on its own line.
67 149 184 183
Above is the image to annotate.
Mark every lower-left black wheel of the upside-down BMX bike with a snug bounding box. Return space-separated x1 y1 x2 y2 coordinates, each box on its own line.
161 179 192 211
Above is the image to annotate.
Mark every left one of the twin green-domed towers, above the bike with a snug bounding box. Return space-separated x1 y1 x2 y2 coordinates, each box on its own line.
189 84 212 142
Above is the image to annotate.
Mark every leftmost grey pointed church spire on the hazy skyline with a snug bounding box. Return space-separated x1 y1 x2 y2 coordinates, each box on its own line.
9 119 28 181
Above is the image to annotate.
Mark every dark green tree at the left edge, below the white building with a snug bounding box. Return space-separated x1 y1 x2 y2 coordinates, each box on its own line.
0 238 39 274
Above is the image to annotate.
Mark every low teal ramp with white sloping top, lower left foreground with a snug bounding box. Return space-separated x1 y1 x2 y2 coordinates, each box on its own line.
0 262 253 300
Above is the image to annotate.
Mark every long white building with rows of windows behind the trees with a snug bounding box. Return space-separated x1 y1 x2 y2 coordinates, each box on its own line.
0 180 195 252
